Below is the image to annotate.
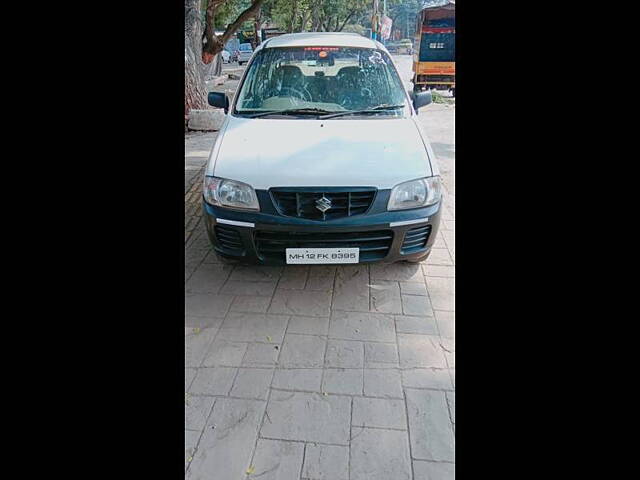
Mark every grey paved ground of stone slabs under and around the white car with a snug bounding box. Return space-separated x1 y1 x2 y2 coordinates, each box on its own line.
185 89 455 480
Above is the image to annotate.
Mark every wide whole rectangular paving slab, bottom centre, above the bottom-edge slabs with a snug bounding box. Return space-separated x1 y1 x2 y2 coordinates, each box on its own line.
260 390 351 445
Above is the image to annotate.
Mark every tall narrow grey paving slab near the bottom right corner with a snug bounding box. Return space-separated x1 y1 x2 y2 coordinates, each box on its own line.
405 389 455 462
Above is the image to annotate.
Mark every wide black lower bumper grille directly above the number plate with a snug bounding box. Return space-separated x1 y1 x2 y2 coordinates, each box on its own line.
255 230 393 261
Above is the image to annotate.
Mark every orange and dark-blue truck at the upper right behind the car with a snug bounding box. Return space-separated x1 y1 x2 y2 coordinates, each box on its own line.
413 0 456 96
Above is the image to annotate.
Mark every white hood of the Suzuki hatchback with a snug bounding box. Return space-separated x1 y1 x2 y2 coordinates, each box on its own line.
207 116 432 189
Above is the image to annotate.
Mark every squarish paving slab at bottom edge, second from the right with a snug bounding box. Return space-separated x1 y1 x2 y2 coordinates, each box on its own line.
349 427 411 480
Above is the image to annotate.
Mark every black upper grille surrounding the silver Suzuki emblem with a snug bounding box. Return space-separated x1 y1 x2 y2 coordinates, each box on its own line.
271 188 376 220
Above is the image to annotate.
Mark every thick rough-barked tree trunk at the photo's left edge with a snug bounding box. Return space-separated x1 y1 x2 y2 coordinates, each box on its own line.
184 0 207 120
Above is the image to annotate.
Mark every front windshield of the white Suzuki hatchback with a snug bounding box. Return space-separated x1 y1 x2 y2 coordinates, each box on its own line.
235 47 410 118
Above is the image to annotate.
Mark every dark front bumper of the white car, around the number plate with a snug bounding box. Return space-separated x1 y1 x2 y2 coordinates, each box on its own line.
203 200 442 265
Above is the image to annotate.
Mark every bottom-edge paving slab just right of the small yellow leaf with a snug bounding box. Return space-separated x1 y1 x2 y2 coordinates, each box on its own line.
249 438 304 480
